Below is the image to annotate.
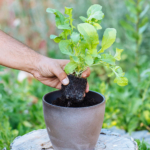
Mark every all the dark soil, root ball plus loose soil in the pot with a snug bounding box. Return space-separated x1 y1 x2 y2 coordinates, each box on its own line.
52 75 99 107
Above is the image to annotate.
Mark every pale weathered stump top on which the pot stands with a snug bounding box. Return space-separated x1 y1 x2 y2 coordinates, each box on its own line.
11 129 138 150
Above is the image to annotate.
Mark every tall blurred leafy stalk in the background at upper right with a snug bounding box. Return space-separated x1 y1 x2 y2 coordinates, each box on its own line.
120 0 149 82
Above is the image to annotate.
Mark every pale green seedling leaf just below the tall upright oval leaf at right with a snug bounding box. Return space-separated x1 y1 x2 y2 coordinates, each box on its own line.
101 54 115 65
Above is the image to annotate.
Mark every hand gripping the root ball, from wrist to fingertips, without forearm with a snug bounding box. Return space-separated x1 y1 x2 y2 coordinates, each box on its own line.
32 56 90 93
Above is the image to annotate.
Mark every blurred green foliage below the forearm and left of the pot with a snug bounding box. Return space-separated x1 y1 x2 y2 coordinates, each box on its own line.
0 66 53 150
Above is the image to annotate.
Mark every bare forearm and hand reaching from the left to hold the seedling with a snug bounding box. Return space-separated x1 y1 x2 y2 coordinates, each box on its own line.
0 30 90 92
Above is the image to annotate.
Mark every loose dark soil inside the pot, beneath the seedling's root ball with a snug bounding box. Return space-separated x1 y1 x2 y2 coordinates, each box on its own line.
52 97 99 107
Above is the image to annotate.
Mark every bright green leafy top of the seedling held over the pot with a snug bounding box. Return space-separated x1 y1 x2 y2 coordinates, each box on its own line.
46 4 128 86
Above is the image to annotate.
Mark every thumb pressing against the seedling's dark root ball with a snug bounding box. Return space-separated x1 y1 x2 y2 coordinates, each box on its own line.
53 65 69 85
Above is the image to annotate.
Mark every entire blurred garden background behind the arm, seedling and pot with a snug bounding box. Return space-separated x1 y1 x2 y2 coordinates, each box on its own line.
0 0 150 149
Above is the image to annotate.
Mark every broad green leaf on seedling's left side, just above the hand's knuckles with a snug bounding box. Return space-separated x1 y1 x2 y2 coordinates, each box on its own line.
59 40 73 56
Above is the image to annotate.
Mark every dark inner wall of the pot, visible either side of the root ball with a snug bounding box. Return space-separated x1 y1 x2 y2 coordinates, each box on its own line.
43 90 105 104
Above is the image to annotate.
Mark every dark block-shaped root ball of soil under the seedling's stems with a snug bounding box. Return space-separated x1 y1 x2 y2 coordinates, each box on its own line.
61 75 87 102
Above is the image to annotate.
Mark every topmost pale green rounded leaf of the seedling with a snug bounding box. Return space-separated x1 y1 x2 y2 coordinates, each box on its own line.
87 4 104 20
